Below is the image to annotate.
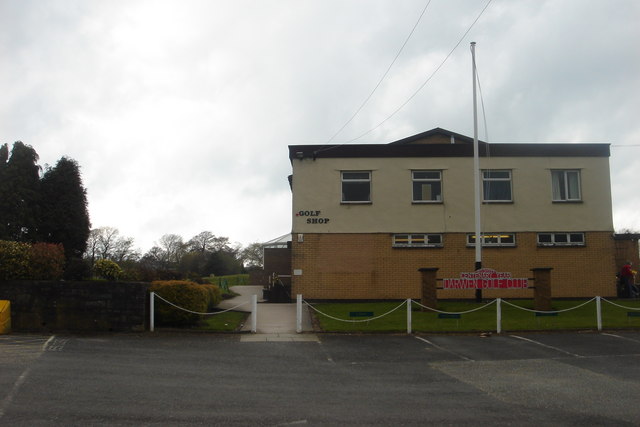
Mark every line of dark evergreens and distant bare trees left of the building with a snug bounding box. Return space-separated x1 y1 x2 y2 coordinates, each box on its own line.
0 141 262 281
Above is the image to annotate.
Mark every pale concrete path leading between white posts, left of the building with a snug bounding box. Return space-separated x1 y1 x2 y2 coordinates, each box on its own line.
217 286 313 341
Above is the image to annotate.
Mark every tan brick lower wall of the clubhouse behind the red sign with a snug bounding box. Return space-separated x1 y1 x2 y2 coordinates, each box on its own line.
292 232 617 299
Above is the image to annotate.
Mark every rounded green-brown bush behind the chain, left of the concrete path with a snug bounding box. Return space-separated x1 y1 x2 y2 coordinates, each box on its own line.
149 280 210 326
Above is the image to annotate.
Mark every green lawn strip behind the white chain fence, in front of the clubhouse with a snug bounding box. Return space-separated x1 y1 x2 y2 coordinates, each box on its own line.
311 299 640 332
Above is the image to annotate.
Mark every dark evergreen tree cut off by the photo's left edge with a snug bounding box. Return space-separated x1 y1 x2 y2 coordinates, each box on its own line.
0 141 40 242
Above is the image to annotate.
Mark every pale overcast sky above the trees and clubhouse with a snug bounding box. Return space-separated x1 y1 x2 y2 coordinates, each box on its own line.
0 0 640 251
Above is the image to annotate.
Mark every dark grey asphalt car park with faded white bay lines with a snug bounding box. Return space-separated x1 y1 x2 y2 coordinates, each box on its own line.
0 332 640 426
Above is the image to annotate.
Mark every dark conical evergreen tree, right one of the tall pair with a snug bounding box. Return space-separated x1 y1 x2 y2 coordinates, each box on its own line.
39 157 91 260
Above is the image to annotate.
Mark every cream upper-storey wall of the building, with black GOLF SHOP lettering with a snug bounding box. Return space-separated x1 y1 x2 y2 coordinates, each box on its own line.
292 157 613 233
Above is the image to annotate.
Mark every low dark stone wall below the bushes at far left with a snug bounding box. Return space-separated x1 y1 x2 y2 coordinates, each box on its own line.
0 280 149 332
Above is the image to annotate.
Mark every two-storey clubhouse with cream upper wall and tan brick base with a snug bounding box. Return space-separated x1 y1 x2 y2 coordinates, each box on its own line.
289 128 617 299
